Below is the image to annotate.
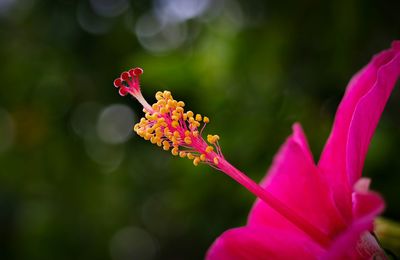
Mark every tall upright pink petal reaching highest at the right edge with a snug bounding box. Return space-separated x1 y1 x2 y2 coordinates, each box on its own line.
319 41 400 219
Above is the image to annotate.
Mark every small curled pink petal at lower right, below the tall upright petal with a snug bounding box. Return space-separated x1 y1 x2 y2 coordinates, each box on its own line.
323 192 385 259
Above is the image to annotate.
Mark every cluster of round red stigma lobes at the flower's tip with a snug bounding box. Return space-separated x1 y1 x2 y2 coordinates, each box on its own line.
114 68 143 96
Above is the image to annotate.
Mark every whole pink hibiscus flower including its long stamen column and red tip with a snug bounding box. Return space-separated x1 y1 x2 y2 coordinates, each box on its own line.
114 41 400 260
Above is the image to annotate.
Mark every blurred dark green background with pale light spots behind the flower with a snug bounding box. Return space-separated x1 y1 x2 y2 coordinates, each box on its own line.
0 0 400 260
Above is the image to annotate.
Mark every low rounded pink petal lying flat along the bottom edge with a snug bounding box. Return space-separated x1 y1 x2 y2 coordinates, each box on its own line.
206 227 324 260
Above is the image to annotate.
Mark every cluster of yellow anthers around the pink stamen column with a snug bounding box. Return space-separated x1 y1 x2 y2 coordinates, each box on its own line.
133 91 222 166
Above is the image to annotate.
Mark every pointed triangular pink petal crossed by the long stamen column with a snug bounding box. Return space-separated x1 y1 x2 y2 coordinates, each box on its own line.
248 124 345 238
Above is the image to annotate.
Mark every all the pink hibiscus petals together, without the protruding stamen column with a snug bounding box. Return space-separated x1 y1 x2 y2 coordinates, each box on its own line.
207 41 400 260
